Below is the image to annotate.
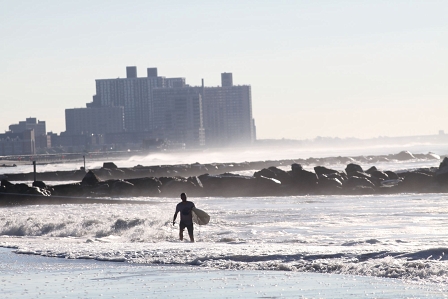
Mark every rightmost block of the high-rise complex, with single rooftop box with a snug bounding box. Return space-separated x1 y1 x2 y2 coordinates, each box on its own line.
202 73 256 146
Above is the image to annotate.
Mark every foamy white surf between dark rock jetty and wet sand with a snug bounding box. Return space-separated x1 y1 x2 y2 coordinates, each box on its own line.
0 194 448 282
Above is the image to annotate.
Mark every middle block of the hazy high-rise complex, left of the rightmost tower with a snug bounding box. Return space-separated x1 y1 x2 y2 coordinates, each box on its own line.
153 87 205 148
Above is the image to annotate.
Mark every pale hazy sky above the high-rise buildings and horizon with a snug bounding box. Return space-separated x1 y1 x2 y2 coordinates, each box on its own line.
0 0 448 139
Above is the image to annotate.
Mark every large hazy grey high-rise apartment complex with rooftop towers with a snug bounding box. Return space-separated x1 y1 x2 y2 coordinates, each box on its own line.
66 66 255 148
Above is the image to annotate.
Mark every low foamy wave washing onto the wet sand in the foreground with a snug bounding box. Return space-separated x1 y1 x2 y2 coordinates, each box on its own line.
0 240 448 283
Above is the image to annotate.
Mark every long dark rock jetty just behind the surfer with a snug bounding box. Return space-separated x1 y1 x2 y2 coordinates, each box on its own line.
0 152 448 202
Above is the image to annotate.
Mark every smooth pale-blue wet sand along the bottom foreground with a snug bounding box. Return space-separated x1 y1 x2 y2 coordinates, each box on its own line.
0 248 448 298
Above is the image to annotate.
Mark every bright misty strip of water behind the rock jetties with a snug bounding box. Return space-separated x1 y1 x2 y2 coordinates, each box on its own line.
0 144 448 174
